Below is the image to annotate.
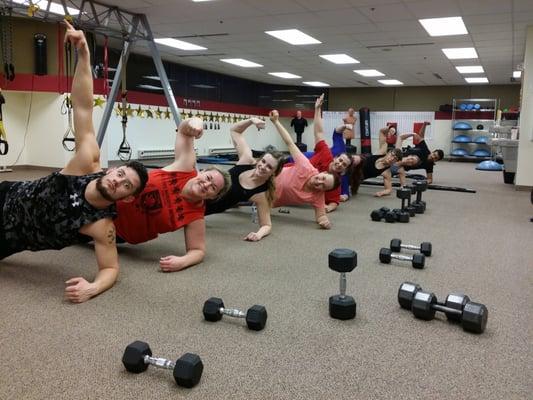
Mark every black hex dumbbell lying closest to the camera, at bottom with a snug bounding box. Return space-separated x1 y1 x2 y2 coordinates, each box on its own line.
122 340 204 388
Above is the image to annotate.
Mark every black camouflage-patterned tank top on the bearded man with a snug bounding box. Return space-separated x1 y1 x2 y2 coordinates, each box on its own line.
2 172 116 252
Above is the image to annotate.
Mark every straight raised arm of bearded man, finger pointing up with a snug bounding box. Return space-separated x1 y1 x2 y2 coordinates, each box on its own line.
62 21 101 175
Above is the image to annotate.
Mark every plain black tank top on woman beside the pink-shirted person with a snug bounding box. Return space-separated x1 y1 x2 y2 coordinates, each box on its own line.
205 164 268 215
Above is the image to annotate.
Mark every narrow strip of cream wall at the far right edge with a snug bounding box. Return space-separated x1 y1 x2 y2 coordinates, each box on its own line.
515 25 533 186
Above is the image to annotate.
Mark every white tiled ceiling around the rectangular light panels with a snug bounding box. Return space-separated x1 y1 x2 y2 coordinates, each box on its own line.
95 0 533 87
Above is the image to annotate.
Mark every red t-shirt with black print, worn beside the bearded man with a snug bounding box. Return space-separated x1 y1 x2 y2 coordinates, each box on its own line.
114 169 205 244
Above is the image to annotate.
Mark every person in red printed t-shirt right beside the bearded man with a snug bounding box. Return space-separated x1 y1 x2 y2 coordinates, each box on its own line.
114 117 230 272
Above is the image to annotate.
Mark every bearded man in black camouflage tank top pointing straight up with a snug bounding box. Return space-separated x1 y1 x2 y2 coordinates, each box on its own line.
0 21 147 303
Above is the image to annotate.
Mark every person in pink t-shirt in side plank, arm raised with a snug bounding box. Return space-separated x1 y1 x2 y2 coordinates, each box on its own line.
270 110 340 229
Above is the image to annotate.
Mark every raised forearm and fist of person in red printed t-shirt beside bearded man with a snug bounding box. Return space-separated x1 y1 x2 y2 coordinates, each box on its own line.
163 117 204 171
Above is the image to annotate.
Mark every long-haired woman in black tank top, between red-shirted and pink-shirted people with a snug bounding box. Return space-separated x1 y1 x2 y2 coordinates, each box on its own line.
205 118 285 242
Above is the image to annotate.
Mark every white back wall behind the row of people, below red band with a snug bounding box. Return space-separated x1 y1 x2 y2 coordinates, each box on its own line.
0 91 458 168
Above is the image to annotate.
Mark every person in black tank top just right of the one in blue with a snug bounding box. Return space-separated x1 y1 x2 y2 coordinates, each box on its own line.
350 149 402 197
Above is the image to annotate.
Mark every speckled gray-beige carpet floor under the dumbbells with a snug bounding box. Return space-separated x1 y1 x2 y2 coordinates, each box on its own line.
0 162 533 399
